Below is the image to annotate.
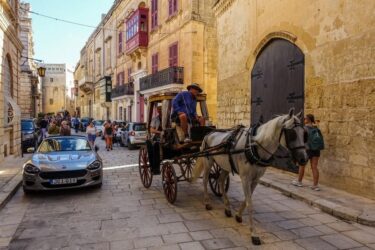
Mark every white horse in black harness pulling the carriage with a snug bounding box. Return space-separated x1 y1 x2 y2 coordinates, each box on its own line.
193 109 308 245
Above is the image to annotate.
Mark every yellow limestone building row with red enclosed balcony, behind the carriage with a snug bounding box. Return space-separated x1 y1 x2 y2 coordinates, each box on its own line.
75 0 216 122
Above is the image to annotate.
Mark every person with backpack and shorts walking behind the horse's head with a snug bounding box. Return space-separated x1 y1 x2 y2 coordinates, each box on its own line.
292 114 324 191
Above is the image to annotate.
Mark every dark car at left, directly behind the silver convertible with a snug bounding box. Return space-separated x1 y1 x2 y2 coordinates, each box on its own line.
21 119 42 152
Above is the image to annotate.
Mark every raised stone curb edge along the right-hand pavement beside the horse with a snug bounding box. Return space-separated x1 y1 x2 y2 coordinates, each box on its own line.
259 177 375 227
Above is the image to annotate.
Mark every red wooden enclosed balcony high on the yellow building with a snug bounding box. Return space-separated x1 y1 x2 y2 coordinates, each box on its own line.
126 8 148 54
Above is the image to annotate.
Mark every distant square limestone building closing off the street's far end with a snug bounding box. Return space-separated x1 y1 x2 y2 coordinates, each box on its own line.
42 63 67 113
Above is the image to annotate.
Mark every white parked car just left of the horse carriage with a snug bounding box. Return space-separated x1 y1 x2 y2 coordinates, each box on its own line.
121 122 147 149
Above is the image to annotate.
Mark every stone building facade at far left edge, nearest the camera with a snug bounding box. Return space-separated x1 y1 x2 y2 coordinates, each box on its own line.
0 0 22 162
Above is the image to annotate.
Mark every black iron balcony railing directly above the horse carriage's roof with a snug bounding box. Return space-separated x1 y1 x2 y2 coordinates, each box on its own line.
140 67 184 91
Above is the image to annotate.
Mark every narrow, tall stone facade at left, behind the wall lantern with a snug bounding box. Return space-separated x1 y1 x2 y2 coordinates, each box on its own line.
19 3 42 118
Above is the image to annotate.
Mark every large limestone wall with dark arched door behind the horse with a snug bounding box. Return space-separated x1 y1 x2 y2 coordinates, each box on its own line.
214 0 375 198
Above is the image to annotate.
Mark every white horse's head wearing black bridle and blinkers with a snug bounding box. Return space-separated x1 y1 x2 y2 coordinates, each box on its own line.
280 109 308 166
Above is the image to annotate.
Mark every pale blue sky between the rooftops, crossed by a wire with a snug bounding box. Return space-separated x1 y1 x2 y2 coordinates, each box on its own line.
24 0 113 66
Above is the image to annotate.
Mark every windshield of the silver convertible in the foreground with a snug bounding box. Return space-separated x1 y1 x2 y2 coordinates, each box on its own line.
38 137 91 153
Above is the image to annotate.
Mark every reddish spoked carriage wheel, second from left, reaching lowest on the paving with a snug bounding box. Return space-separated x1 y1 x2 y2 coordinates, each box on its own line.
162 162 177 204
